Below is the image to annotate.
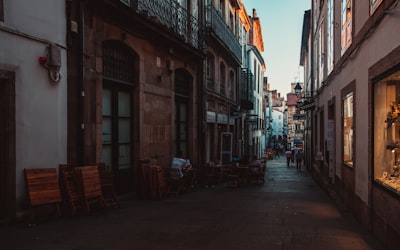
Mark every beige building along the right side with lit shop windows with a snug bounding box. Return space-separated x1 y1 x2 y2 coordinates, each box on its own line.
301 0 400 249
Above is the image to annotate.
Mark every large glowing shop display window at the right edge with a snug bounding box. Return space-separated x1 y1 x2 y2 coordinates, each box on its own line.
373 70 400 194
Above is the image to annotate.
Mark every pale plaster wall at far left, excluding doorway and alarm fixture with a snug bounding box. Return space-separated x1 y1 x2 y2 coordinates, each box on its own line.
0 0 67 207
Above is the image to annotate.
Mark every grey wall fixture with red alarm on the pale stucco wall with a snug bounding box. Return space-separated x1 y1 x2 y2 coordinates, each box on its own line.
39 45 61 83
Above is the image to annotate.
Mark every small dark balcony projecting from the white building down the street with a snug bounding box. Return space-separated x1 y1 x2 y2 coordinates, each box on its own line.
239 69 254 110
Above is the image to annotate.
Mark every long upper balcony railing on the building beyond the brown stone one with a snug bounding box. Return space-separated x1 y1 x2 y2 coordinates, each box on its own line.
206 4 242 61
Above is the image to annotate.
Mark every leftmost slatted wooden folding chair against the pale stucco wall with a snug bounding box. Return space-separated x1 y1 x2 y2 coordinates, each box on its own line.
24 168 62 224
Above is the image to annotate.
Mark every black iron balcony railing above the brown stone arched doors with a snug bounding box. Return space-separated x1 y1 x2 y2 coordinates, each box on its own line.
120 0 200 49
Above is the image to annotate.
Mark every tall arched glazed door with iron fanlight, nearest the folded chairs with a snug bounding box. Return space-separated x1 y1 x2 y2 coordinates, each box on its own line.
102 41 138 172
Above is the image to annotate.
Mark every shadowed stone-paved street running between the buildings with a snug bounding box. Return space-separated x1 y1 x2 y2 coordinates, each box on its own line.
0 157 384 250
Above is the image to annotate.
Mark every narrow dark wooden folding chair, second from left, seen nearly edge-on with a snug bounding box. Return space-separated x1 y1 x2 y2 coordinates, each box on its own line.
58 164 82 216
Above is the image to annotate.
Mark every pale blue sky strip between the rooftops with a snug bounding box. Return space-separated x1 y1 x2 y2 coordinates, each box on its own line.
242 0 311 95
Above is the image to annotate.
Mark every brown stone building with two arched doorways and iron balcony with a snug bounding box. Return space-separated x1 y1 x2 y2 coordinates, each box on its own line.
67 0 205 192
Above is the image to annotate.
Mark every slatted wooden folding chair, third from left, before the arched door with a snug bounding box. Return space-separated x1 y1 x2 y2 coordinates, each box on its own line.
74 165 105 214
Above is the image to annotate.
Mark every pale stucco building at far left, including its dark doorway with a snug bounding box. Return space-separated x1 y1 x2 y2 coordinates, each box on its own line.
0 0 67 220
